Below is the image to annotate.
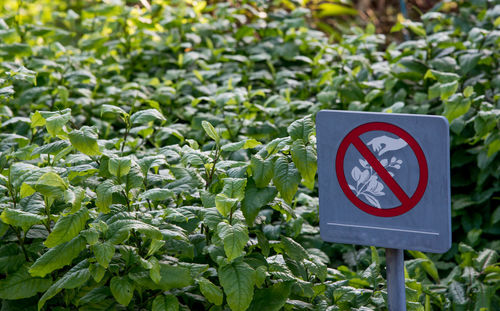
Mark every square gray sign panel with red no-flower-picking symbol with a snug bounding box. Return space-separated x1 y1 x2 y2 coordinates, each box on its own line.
316 110 451 253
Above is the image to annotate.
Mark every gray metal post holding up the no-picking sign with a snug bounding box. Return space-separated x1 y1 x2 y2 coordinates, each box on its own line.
385 248 406 311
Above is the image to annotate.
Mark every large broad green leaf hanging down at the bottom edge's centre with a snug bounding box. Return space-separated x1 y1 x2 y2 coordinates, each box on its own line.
219 261 255 311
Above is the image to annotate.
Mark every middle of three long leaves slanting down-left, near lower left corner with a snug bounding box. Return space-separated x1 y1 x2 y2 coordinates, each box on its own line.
30 236 86 277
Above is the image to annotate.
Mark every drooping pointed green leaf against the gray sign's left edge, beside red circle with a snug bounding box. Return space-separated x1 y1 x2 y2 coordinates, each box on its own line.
292 139 318 190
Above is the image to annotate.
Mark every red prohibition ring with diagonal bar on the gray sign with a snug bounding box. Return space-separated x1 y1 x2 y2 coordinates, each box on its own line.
335 122 429 217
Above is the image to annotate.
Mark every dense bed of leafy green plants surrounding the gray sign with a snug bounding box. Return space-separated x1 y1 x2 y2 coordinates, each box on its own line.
0 0 500 311
